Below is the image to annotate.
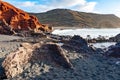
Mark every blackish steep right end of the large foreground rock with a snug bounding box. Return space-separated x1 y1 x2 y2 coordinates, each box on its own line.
47 44 73 68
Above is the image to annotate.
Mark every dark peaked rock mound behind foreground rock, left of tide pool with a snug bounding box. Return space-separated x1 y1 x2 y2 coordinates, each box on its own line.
62 35 93 53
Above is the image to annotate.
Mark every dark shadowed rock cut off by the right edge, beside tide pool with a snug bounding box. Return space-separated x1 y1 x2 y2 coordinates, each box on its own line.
105 42 120 58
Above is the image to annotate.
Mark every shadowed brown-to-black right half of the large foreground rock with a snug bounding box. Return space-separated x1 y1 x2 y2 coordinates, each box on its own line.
31 43 73 69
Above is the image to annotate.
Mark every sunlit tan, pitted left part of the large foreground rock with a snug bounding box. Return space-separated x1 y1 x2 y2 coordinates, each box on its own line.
2 43 33 78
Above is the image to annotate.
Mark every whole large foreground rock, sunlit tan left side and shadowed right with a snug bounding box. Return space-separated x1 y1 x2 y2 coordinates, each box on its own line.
2 43 72 78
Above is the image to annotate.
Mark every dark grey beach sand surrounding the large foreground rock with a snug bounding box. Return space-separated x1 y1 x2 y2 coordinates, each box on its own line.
0 35 120 80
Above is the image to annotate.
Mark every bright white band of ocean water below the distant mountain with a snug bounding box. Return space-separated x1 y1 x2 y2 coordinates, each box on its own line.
52 28 120 38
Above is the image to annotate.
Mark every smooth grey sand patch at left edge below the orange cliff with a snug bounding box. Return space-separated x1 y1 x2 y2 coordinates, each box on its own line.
0 35 21 54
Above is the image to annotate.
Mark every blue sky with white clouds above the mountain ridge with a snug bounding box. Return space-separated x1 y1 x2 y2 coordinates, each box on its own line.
4 0 120 17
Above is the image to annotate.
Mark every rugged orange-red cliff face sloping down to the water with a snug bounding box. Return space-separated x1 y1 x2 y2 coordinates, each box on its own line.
0 0 52 34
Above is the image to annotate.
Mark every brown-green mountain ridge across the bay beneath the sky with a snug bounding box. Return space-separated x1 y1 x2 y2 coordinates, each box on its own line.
30 9 120 28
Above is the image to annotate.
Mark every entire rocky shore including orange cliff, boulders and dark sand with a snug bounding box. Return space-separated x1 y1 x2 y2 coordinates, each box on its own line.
0 0 120 80
